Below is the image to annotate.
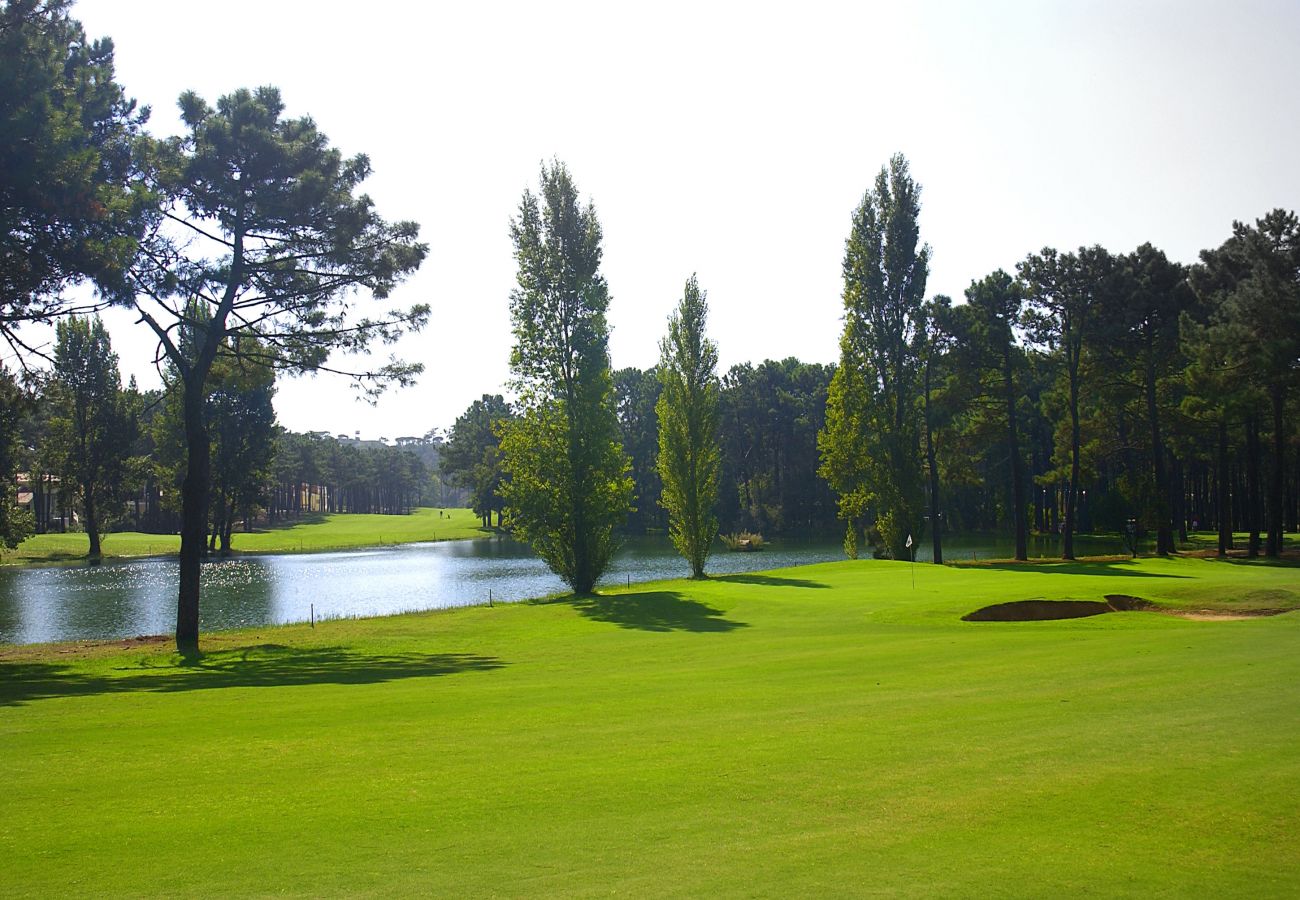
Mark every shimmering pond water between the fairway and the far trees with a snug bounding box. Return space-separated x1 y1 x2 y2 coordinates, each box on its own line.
0 537 1121 644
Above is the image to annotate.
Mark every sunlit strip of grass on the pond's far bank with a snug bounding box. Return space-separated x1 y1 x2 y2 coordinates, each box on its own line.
0 507 493 563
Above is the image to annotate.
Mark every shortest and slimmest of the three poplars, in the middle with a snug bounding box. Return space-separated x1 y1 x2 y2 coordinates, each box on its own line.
655 276 722 579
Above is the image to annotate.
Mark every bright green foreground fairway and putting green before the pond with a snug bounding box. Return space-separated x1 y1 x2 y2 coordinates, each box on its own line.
0 559 1300 897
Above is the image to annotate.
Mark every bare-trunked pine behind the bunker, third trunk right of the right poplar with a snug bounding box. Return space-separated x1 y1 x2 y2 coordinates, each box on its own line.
1017 246 1114 559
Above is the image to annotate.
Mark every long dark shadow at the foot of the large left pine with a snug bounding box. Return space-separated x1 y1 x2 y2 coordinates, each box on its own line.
0 644 506 706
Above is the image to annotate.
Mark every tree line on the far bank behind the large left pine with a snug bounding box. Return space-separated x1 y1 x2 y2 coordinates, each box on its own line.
3 316 444 558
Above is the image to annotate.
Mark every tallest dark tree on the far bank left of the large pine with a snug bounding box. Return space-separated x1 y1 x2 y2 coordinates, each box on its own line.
47 316 135 562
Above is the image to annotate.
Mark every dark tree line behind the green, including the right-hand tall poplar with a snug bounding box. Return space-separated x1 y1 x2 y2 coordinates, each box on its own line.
445 156 1300 572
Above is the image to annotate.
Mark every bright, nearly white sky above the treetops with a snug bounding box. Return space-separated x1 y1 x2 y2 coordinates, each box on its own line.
45 0 1300 440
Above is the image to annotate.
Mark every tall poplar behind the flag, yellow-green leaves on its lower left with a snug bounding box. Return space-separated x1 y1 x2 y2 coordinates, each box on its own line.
819 153 930 558
